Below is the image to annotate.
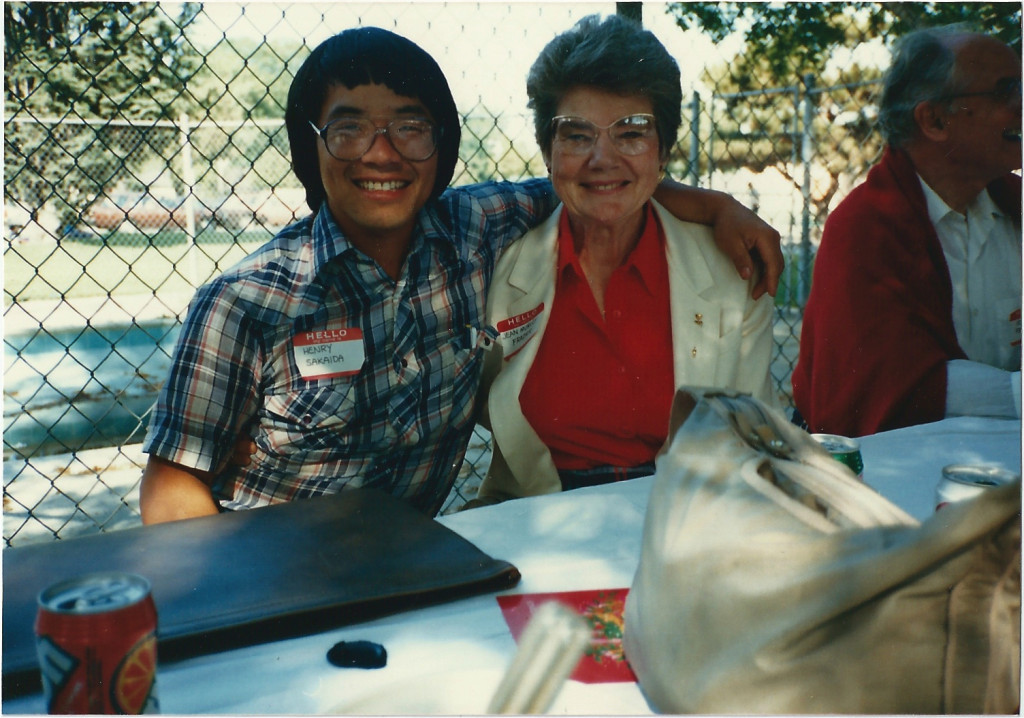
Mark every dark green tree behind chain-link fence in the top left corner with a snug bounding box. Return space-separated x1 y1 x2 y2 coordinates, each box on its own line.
4 2 200 226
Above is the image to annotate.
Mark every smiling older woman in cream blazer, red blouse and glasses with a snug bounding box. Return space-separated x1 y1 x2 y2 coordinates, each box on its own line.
471 16 773 506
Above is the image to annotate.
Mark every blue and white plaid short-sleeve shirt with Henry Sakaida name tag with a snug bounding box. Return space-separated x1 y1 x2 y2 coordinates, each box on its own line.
143 180 556 515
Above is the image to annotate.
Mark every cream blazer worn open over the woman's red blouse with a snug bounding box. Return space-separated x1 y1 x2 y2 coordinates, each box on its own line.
478 200 777 501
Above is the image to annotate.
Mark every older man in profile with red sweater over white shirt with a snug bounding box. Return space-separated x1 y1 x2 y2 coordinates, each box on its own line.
793 28 1021 436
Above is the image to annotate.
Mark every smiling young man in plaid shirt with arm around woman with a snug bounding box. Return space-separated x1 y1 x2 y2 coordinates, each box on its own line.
140 28 781 523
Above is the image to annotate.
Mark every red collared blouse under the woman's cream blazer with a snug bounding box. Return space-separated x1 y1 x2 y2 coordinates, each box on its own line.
519 204 675 469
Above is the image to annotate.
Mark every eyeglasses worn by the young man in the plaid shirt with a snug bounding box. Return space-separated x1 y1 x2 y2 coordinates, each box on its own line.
309 117 437 162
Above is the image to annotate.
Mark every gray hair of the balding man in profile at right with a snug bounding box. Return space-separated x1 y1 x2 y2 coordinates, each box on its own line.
879 24 974 147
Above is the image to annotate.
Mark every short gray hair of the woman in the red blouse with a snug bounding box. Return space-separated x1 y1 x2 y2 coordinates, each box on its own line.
526 15 683 158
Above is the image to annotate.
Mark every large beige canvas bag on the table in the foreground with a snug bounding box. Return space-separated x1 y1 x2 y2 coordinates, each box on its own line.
624 389 1021 714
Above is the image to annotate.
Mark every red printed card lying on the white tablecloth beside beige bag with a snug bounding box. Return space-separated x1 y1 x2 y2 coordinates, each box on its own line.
498 588 637 683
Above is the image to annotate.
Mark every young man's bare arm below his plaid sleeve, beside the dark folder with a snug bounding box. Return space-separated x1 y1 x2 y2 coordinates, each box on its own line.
139 456 219 524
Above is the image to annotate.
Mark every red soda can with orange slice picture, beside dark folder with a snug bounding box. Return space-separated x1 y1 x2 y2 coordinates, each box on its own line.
36 573 159 714
